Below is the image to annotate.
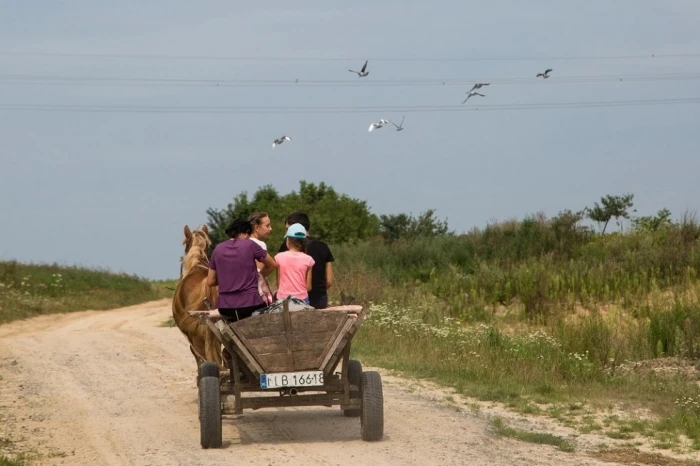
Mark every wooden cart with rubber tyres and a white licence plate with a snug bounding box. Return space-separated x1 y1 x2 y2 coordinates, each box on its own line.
190 301 384 448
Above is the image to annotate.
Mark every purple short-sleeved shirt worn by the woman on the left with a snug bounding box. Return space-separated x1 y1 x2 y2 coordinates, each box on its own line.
209 239 267 309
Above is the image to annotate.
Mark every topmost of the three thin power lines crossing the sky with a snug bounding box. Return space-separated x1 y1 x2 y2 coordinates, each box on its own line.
0 51 700 62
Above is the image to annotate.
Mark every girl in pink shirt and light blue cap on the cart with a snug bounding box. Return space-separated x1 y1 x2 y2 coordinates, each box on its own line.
275 223 314 304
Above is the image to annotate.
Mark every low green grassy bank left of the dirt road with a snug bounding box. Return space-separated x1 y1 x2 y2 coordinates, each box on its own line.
0 261 173 324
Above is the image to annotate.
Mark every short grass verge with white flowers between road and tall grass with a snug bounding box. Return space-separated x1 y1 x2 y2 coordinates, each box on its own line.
353 296 700 442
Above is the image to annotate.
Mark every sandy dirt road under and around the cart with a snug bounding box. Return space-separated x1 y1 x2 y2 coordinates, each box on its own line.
0 300 611 466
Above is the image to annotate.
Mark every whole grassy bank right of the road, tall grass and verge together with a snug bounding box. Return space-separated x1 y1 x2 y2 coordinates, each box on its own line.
332 213 700 446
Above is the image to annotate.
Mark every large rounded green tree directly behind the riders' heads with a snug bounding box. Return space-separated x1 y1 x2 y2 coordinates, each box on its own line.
207 181 379 247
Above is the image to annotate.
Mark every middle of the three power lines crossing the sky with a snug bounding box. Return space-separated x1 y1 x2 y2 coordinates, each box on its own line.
0 73 700 87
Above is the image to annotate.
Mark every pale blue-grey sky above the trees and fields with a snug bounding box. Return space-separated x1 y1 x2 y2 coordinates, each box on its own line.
0 0 700 279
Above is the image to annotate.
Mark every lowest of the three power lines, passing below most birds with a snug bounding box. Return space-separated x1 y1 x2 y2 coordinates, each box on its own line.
0 98 700 114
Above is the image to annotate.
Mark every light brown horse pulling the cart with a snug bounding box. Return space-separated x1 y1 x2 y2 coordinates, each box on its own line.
173 225 222 374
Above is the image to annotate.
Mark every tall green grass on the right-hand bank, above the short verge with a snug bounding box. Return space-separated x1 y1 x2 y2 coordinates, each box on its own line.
334 216 700 320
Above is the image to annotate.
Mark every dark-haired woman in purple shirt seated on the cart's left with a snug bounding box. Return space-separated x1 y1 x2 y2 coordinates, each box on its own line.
207 219 277 321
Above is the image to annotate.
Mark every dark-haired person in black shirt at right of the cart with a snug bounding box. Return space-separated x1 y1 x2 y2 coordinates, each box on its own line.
279 212 335 309
